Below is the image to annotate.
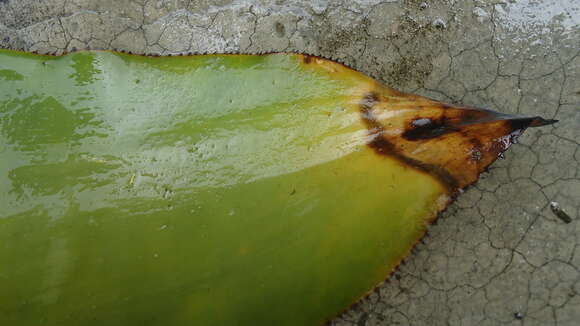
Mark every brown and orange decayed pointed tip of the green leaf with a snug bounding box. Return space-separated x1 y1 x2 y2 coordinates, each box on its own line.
359 87 555 194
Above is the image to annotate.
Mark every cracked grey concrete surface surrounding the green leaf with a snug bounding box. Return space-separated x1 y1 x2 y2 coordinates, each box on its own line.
0 0 580 326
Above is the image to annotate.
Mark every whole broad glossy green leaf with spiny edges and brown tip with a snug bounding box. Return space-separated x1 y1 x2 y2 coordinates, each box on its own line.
0 51 553 326
